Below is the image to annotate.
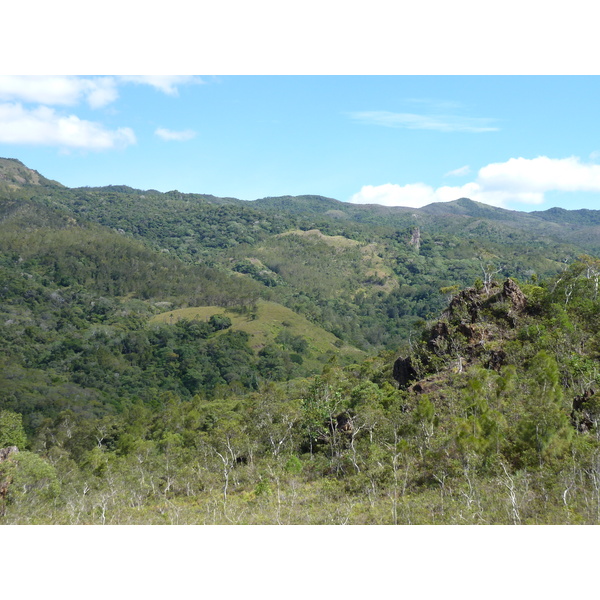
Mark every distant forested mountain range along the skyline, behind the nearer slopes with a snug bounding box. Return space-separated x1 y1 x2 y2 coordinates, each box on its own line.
0 159 600 351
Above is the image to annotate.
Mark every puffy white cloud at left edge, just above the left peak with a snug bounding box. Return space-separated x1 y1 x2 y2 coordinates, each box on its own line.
0 103 136 150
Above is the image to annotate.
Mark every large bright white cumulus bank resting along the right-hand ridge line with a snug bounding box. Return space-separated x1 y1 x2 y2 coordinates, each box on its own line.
350 156 600 208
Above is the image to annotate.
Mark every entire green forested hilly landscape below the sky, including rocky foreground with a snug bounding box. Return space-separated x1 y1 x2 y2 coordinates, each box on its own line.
0 159 600 524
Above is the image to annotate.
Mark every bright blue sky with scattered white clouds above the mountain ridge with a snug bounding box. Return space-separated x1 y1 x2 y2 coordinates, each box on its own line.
0 75 600 211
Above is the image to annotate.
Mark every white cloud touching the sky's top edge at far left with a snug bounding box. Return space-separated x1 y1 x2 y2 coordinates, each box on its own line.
0 75 118 108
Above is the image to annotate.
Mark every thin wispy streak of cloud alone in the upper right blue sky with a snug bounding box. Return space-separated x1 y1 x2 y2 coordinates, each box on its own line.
349 110 498 133
